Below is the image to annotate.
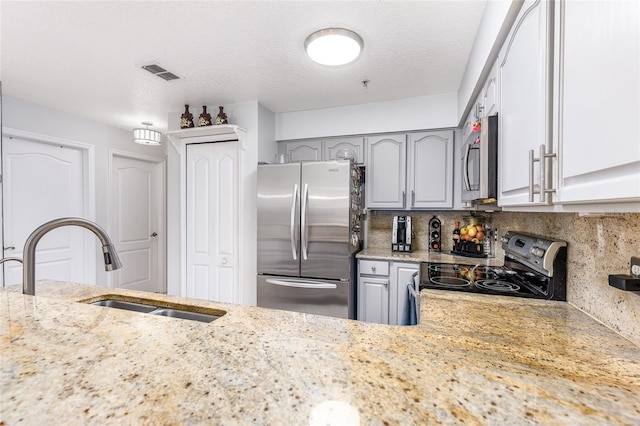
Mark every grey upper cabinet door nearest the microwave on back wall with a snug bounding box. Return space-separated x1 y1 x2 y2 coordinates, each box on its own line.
407 130 453 209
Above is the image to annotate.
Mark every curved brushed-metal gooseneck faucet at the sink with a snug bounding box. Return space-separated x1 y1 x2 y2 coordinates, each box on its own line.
22 217 122 296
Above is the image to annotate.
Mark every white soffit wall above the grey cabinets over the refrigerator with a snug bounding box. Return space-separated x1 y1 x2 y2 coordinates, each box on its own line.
275 93 458 141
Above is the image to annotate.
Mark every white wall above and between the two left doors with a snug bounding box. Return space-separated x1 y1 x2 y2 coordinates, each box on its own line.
2 96 166 285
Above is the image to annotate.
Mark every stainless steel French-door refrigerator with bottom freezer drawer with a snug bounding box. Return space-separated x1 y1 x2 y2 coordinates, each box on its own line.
257 160 362 318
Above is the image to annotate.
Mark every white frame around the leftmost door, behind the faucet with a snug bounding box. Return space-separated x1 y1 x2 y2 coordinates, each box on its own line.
0 127 97 286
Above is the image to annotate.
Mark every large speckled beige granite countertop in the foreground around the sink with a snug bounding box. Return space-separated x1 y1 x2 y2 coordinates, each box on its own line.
0 282 640 425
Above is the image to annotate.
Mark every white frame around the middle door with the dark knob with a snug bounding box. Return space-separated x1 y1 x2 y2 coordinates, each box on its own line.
107 148 168 293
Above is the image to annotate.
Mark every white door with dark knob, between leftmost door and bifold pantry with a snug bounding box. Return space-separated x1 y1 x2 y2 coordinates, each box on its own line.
110 154 167 293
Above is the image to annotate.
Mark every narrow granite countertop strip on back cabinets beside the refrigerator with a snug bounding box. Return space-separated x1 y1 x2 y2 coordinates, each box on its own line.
356 248 503 266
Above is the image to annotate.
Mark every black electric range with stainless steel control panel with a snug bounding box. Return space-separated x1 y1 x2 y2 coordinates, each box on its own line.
420 231 567 301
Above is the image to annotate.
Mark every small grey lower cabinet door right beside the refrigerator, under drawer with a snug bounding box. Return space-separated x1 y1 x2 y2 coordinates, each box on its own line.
358 276 389 324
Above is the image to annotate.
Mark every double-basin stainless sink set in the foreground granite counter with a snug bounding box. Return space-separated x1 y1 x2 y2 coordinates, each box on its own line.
83 296 226 322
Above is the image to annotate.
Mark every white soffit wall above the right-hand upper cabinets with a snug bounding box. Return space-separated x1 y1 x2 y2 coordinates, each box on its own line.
456 0 523 126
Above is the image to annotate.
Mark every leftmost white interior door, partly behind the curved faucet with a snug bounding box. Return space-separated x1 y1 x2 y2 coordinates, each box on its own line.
2 136 90 285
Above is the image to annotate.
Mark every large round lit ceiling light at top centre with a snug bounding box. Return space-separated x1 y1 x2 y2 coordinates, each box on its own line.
304 28 364 66
